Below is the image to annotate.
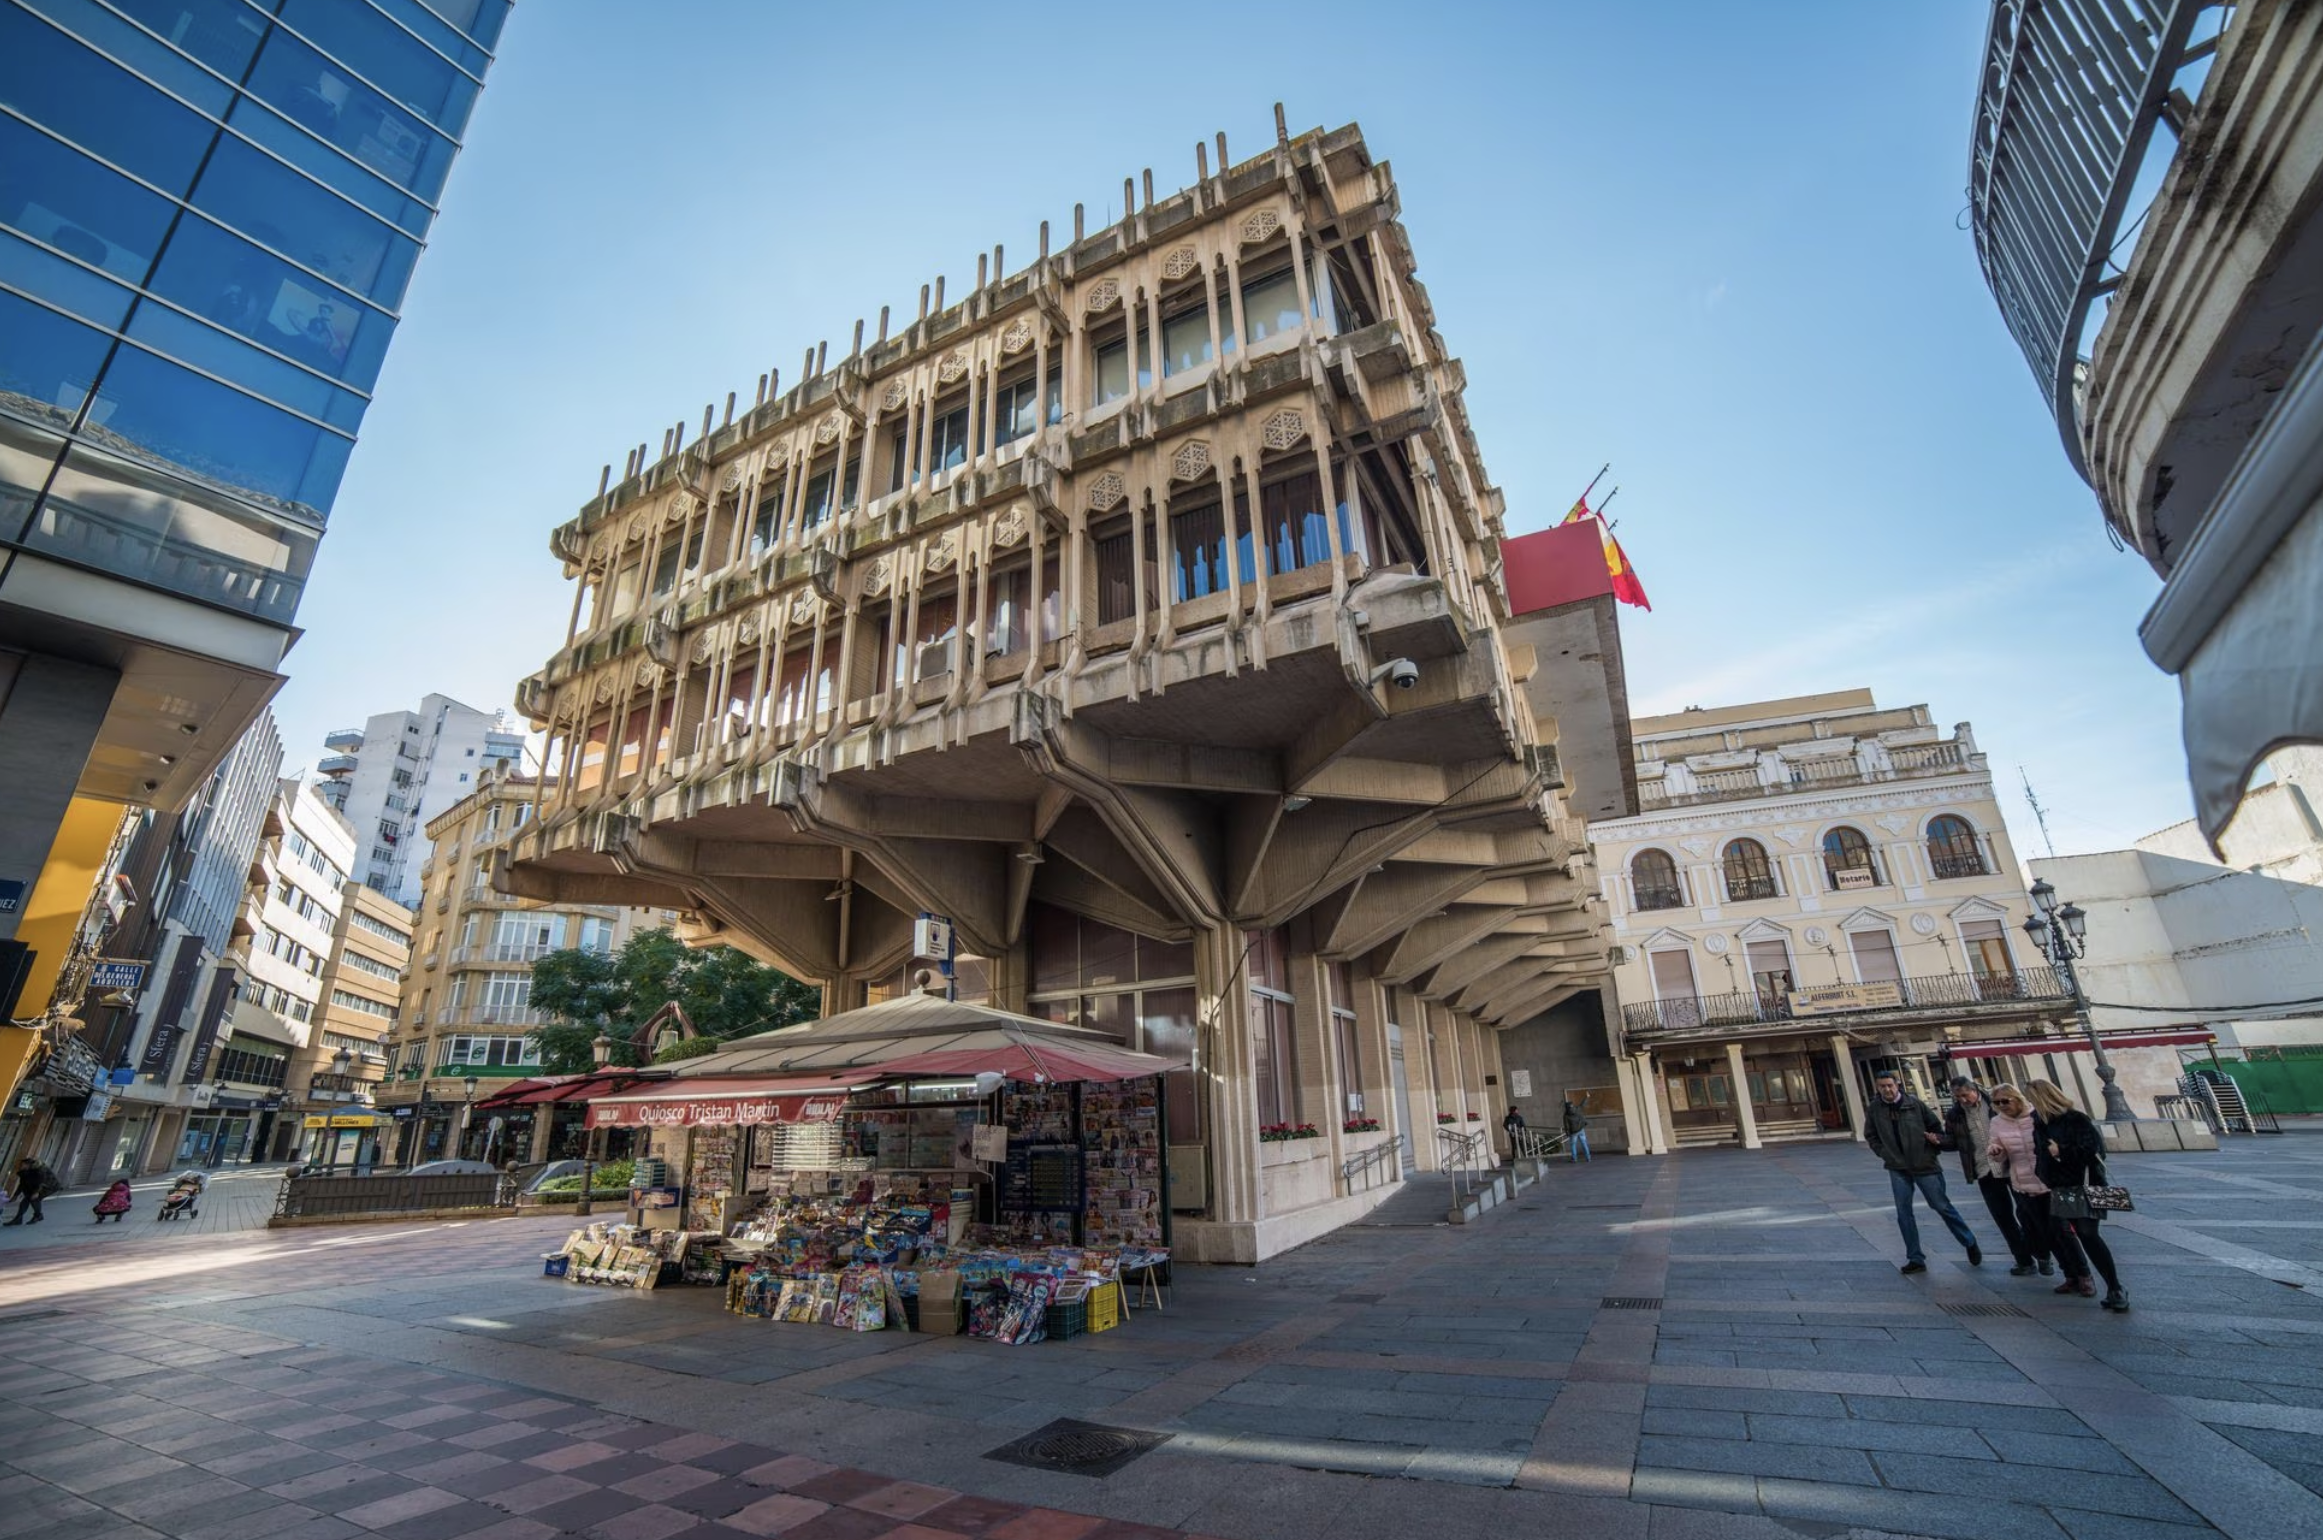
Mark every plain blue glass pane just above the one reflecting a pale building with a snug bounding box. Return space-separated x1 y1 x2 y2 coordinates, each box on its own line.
88 348 351 516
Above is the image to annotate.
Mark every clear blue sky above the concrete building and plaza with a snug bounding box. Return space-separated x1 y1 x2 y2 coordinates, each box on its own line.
279 0 2188 855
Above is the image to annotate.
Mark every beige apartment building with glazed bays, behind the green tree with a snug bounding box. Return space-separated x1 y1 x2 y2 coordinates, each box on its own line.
374 767 671 1164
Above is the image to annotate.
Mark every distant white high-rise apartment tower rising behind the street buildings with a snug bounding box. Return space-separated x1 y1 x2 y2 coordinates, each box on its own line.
318 695 525 908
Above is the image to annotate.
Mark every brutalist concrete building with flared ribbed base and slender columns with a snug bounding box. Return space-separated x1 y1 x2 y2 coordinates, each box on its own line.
499 123 1631 1261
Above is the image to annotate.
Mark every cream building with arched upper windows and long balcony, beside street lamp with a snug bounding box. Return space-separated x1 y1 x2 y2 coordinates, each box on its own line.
1589 690 2090 1152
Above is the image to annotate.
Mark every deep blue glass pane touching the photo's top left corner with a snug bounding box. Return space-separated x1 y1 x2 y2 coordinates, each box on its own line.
0 7 216 193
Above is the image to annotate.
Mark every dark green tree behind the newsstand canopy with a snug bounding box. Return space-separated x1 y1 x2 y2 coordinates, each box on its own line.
532 931 822 1075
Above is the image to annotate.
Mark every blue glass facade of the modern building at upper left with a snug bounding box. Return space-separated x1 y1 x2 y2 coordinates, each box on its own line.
0 0 511 627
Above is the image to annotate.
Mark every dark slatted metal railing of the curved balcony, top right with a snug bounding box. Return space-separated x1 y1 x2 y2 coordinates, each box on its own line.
1968 0 2207 476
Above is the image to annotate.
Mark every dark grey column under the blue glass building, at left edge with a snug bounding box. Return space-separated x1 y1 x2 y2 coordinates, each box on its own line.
0 653 121 947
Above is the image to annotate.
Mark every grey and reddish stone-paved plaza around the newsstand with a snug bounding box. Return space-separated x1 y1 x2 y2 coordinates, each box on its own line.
0 1127 2323 1540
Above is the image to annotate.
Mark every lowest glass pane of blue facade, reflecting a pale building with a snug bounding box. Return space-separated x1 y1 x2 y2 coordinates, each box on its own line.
26 448 316 623
